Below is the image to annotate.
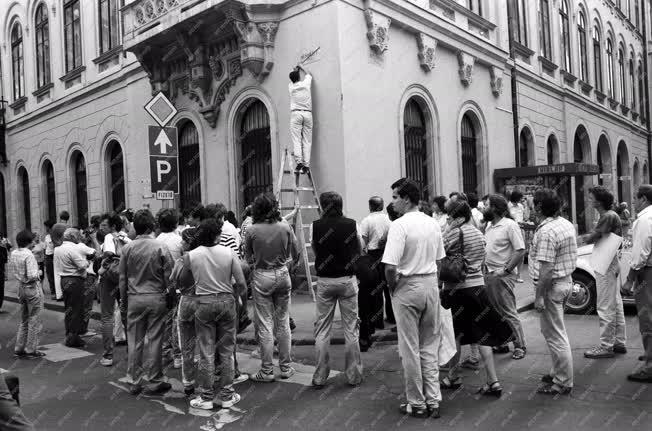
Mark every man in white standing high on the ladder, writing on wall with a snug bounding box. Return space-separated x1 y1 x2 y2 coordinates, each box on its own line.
288 66 312 174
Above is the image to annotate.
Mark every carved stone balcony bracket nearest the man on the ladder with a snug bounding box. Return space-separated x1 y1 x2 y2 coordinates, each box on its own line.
233 21 278 77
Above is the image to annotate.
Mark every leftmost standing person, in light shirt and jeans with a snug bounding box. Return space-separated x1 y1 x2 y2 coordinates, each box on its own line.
9 230 45 358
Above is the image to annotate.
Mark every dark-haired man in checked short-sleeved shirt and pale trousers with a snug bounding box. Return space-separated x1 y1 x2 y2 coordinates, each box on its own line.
528 189 577 395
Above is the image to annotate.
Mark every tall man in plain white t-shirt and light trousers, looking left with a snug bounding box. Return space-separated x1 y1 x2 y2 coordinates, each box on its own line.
382 178 445 418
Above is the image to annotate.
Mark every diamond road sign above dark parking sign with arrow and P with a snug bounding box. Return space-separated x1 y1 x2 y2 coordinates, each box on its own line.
145 93 179 208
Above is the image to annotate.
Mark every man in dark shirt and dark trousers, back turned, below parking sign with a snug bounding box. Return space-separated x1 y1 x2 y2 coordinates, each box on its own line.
119 210 174 395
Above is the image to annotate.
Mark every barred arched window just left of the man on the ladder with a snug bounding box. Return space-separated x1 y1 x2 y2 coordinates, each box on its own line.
240 99 274 209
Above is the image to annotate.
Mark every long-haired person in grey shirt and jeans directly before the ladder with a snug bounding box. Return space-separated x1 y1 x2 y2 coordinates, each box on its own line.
244 193 299 382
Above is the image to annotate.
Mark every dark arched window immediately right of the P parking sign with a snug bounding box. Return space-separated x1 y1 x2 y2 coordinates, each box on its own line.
179 121 201 209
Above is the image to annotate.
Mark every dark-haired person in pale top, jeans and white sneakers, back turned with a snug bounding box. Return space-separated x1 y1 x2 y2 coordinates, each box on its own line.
182 218 246 410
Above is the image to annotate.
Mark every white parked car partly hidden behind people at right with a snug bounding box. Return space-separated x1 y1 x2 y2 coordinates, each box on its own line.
566 238 634 314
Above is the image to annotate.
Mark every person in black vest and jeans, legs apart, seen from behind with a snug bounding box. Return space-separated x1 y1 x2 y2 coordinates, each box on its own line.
312 192 362 389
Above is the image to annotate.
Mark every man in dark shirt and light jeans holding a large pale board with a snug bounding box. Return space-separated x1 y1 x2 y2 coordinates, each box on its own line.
584 186 627 359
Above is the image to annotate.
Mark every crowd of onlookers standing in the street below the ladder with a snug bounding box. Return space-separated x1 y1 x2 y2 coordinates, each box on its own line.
1 178 652 426
